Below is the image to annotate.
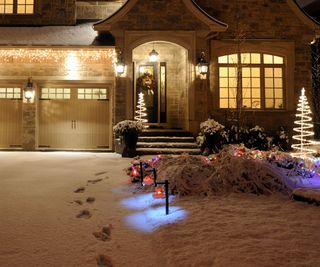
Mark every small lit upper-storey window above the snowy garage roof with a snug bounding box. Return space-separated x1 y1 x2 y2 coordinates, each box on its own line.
0 0 35 15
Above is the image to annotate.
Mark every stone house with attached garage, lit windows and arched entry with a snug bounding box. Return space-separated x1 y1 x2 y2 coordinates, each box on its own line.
0 0 320 150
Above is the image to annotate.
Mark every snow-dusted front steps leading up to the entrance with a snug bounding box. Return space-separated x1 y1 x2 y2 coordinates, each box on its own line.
137 129 200 155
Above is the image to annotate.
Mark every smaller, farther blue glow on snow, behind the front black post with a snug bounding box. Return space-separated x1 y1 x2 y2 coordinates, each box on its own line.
121 193 174 210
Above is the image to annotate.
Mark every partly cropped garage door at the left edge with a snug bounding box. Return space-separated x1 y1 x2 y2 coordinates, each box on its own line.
0 87 22 148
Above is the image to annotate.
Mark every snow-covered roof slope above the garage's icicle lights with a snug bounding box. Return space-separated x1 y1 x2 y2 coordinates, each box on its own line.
0 23 97 46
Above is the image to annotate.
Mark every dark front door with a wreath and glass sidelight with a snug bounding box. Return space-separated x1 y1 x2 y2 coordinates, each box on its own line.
135 62 167 125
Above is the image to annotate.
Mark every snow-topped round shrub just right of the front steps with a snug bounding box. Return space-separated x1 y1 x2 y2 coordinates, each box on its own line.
197 119 228 154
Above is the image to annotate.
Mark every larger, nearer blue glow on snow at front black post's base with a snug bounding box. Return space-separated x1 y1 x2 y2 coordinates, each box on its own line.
125 206 187 233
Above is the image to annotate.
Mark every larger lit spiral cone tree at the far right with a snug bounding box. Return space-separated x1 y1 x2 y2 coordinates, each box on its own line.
291 88 317 158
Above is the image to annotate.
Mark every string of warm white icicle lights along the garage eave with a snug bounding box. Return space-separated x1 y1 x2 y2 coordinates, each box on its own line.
0 48 116 64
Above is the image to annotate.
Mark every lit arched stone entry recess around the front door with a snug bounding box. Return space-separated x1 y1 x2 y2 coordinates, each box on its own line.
132 41 189 129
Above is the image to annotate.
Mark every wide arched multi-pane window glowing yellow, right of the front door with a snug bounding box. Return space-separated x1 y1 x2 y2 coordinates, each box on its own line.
218 53 284 109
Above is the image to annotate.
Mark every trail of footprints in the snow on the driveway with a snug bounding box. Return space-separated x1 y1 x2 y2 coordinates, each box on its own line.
73 172 113 267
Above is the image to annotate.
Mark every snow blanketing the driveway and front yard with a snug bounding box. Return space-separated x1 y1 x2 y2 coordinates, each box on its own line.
0 152 320 267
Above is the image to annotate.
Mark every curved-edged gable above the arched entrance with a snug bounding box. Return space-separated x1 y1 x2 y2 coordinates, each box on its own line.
94 0 228 32
